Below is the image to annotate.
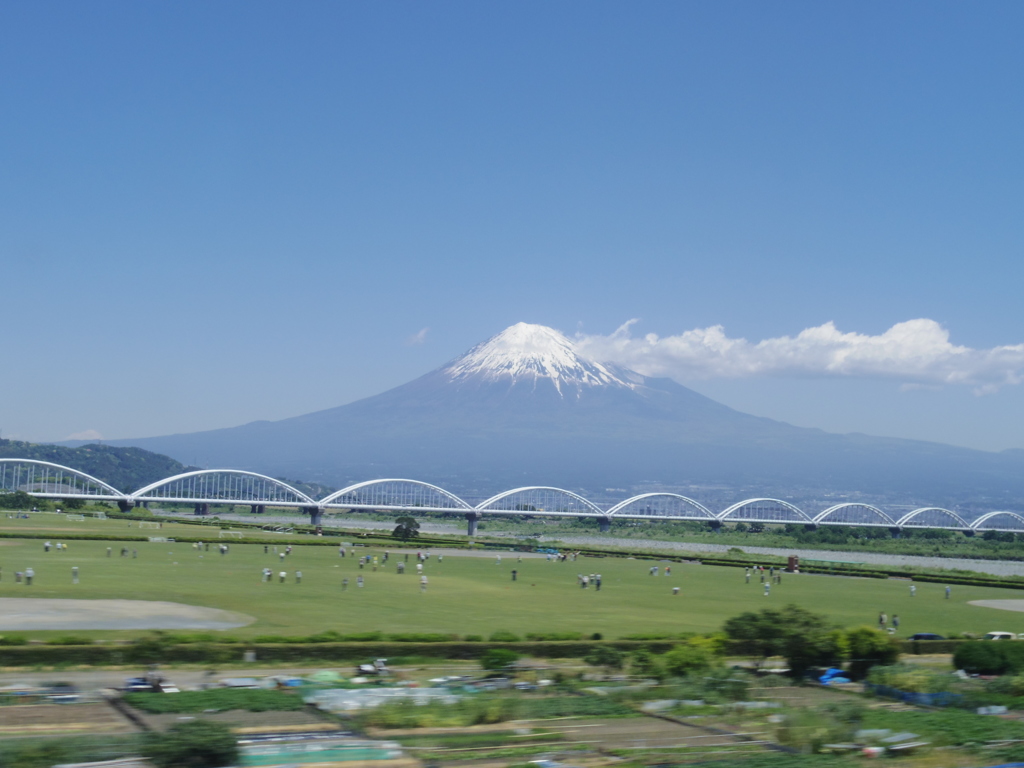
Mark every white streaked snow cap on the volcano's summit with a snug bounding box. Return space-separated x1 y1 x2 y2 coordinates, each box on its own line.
443 323 635 395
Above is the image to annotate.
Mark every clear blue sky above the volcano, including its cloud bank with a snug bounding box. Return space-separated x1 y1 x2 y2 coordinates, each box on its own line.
0 0 1024 450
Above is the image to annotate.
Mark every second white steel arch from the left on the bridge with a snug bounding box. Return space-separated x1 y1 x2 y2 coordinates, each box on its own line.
130 469 316 507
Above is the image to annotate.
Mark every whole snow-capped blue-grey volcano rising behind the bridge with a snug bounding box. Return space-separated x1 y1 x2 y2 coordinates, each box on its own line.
70 324 1024 507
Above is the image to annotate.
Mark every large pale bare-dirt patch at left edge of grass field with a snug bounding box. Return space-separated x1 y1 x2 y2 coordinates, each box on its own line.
0 597 256 632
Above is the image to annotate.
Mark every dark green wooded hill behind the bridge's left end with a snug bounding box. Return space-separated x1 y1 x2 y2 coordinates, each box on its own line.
0 439 196 492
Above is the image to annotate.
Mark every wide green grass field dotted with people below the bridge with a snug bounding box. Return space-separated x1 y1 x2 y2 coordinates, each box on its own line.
0 515 1024 639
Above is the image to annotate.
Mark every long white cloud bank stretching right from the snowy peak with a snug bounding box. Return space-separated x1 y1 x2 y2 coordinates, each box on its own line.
577 317 1024 394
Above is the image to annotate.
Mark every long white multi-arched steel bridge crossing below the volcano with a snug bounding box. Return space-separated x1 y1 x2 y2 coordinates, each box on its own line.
0 459 1024 535
